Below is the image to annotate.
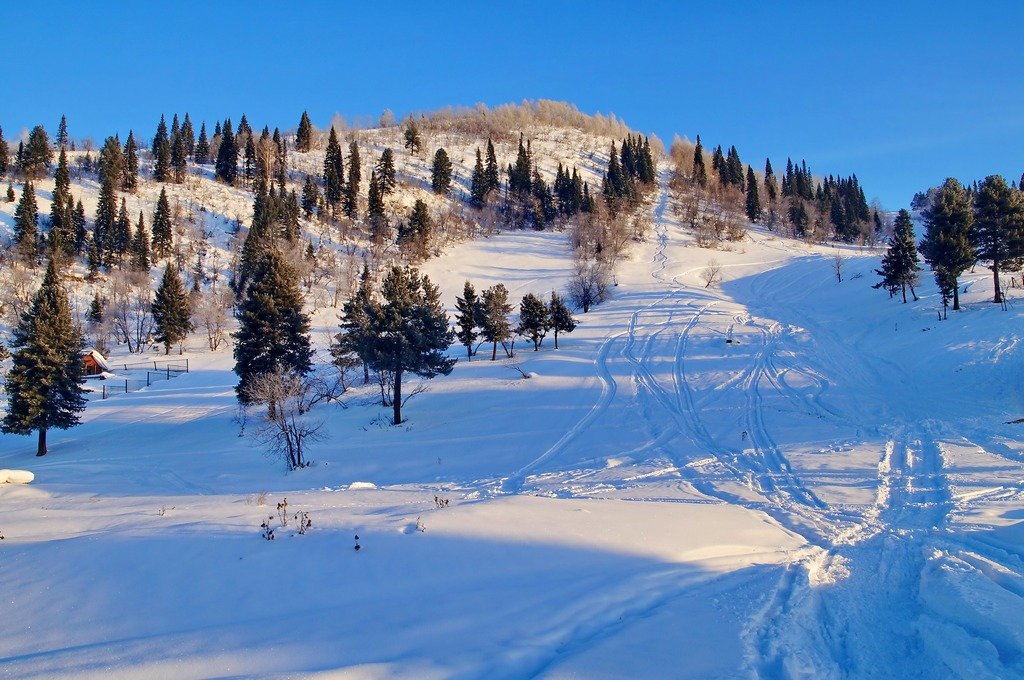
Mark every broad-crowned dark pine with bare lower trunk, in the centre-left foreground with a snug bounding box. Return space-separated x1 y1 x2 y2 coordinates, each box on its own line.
362 266 456 425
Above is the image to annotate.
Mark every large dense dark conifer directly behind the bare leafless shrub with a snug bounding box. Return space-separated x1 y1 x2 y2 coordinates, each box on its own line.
234 249 312 403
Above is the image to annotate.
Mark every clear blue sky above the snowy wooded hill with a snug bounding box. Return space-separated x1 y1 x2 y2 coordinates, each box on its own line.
0 0 1024 208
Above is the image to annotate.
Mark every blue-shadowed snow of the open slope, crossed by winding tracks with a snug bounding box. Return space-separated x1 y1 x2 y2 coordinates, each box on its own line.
0 157 1024 678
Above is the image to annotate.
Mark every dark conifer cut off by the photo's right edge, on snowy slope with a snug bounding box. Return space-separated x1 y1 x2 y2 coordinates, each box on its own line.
969 175 1024 302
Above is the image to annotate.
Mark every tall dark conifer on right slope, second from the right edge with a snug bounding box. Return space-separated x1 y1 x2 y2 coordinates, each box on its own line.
921 177 976 310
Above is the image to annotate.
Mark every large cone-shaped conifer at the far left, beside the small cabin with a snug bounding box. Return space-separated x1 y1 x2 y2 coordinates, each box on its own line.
0 261 85 456
